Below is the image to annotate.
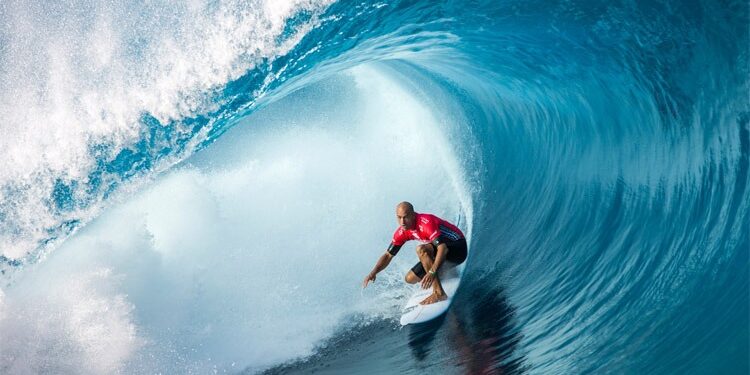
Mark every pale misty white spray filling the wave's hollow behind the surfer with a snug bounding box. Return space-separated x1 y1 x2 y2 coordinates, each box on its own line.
0 68 470 373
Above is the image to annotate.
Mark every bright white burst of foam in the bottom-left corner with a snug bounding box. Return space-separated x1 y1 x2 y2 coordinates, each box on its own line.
0 264 142 374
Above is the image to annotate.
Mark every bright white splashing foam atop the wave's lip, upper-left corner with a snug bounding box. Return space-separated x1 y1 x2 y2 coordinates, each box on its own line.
0 0 330 258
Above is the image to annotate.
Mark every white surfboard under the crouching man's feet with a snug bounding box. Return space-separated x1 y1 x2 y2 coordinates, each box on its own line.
401 266 463 326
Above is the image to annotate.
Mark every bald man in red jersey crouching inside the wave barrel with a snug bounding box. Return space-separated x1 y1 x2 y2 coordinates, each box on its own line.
362 202 467 305
